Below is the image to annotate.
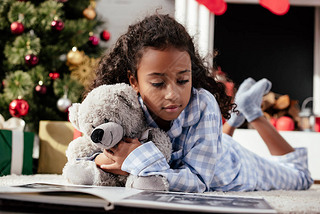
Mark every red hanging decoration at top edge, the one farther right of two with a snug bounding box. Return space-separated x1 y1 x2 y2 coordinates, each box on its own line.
259 0 290 15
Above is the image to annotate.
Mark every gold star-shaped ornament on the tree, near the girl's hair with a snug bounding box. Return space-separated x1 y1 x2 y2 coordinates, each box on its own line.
69 55 98 88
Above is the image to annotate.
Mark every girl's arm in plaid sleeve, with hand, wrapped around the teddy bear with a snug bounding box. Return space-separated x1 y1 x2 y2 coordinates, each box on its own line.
101 113 221 192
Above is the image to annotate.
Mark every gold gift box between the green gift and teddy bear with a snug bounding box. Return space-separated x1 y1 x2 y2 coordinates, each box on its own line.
38 120 75 174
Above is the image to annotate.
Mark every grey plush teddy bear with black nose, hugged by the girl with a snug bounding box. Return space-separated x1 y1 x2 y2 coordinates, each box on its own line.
62 83 172 190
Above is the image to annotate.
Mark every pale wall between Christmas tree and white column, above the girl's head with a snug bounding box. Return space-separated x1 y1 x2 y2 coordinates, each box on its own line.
95 0 175 47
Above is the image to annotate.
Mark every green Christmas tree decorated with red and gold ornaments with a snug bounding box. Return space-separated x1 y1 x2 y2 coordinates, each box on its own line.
0 0 110 133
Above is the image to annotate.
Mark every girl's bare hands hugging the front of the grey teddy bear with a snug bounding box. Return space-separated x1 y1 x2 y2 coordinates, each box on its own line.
100 138 141 175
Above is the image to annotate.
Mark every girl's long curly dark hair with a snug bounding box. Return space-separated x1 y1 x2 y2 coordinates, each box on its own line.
88 14 235 119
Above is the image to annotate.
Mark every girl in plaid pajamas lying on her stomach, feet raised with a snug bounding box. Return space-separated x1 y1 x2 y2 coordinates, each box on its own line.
91 15 313 192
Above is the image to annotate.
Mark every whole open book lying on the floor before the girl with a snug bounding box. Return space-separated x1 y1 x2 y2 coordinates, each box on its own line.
0 183 276 213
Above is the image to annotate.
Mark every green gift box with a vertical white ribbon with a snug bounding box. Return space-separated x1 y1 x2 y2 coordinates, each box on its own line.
0 130 34 176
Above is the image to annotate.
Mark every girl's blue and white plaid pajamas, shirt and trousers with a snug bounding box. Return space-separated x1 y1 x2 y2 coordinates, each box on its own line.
122 89 313 192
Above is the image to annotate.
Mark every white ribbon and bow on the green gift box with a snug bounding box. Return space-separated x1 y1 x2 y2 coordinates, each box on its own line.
0 114 25 175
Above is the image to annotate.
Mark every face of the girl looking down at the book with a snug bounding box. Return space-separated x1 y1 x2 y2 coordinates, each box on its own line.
129 48 192 127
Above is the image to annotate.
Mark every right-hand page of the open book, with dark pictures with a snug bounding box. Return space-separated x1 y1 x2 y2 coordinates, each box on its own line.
119 191 276 213
